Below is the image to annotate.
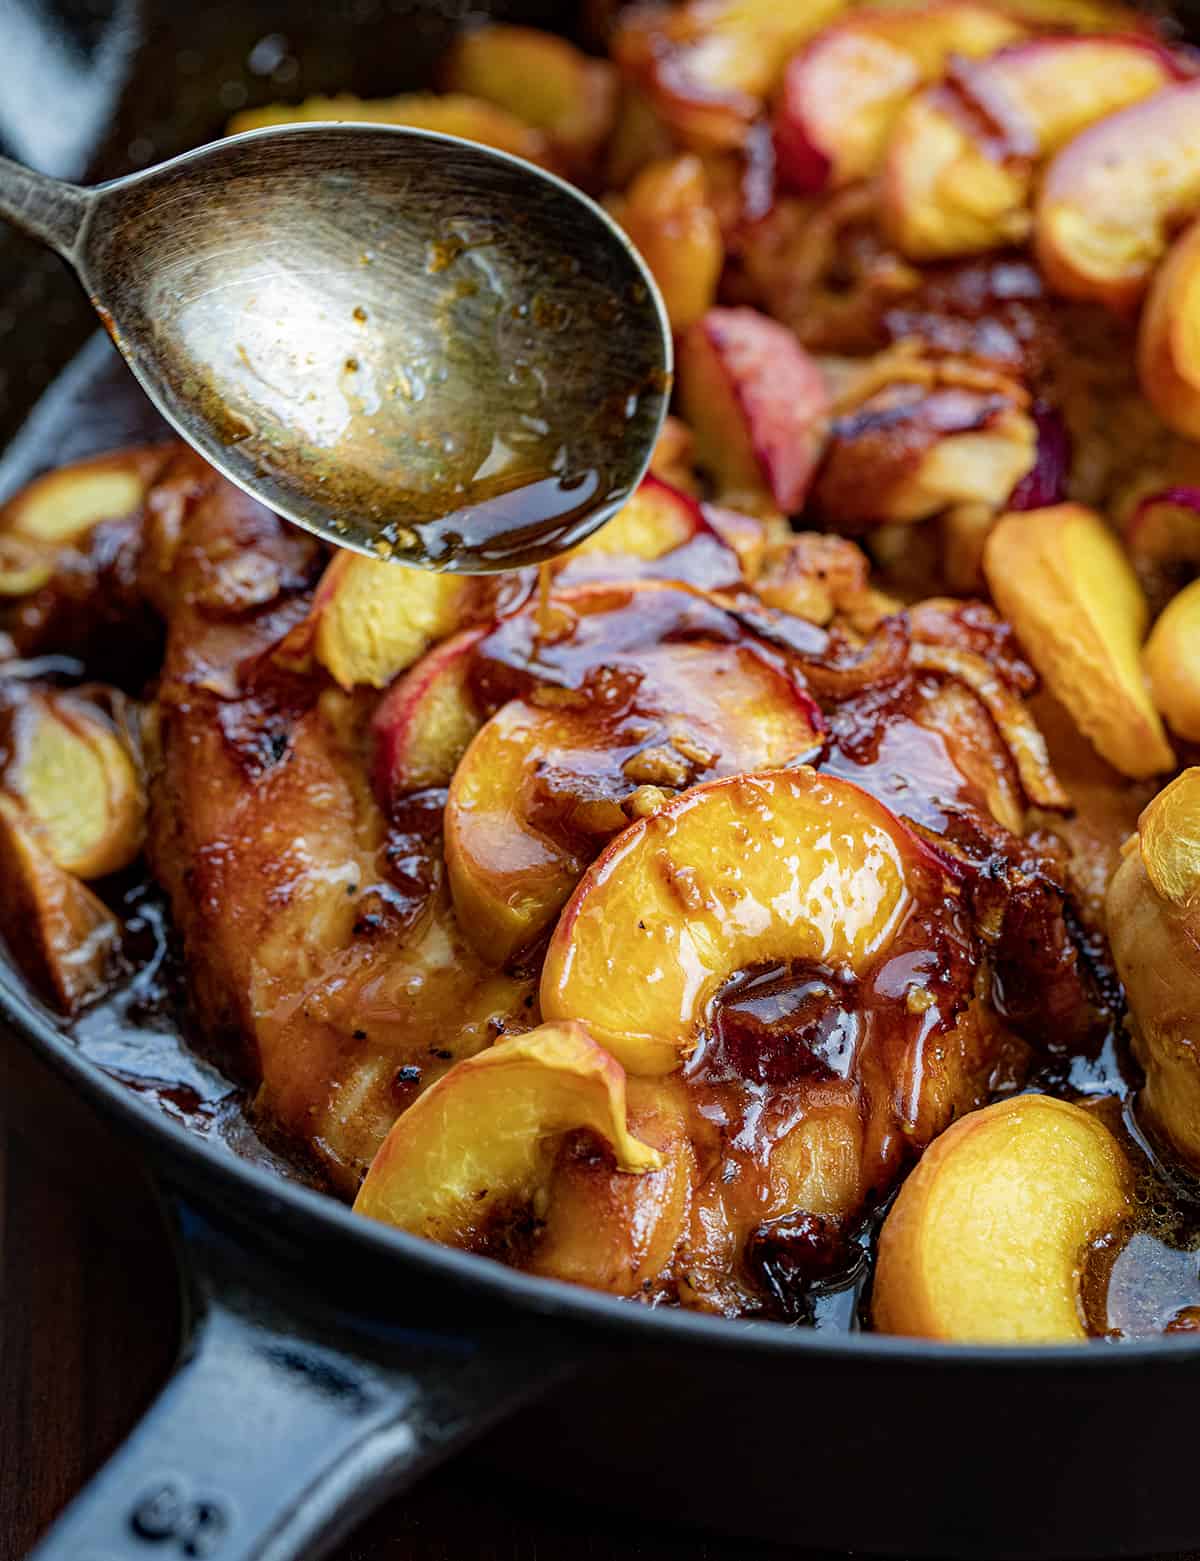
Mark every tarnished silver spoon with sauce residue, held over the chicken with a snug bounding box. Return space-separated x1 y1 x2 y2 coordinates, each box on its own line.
0 125 671 573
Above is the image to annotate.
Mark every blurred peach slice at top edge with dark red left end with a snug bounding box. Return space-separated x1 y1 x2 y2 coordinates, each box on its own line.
774 0 1025 192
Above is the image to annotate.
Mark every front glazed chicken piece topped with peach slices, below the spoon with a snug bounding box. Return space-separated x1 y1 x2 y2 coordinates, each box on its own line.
0 437 1100 1316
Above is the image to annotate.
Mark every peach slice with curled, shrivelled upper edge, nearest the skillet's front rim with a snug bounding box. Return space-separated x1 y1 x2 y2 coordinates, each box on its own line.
354 1024 663 1255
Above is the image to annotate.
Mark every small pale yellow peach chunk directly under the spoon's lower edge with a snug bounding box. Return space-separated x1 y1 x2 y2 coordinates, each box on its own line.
307 553 473 688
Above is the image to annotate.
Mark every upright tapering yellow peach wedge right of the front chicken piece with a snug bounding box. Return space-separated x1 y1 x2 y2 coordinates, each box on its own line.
983 504 1175 779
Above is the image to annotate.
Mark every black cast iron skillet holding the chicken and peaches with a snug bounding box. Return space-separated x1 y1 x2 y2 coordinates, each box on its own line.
0 0 1200 1561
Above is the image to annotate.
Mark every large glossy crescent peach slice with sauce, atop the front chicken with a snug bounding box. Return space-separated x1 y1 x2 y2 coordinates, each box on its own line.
541 768 938 1074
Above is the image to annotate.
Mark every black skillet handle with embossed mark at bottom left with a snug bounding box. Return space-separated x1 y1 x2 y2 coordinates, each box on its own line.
28 1208 573 1561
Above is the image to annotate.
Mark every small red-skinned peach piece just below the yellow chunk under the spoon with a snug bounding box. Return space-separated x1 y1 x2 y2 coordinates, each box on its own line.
371 629 485 812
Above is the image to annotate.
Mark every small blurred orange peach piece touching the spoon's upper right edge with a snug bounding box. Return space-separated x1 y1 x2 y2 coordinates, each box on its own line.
615 156 726 331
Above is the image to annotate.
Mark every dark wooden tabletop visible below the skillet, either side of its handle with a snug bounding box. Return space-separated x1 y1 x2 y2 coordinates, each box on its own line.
0 1033 819 1561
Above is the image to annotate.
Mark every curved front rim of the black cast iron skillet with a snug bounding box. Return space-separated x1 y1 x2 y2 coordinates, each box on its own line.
0 957 1200 1372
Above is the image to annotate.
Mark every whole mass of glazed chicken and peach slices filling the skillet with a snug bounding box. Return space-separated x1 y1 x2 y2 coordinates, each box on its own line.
11 0 1200 1339
